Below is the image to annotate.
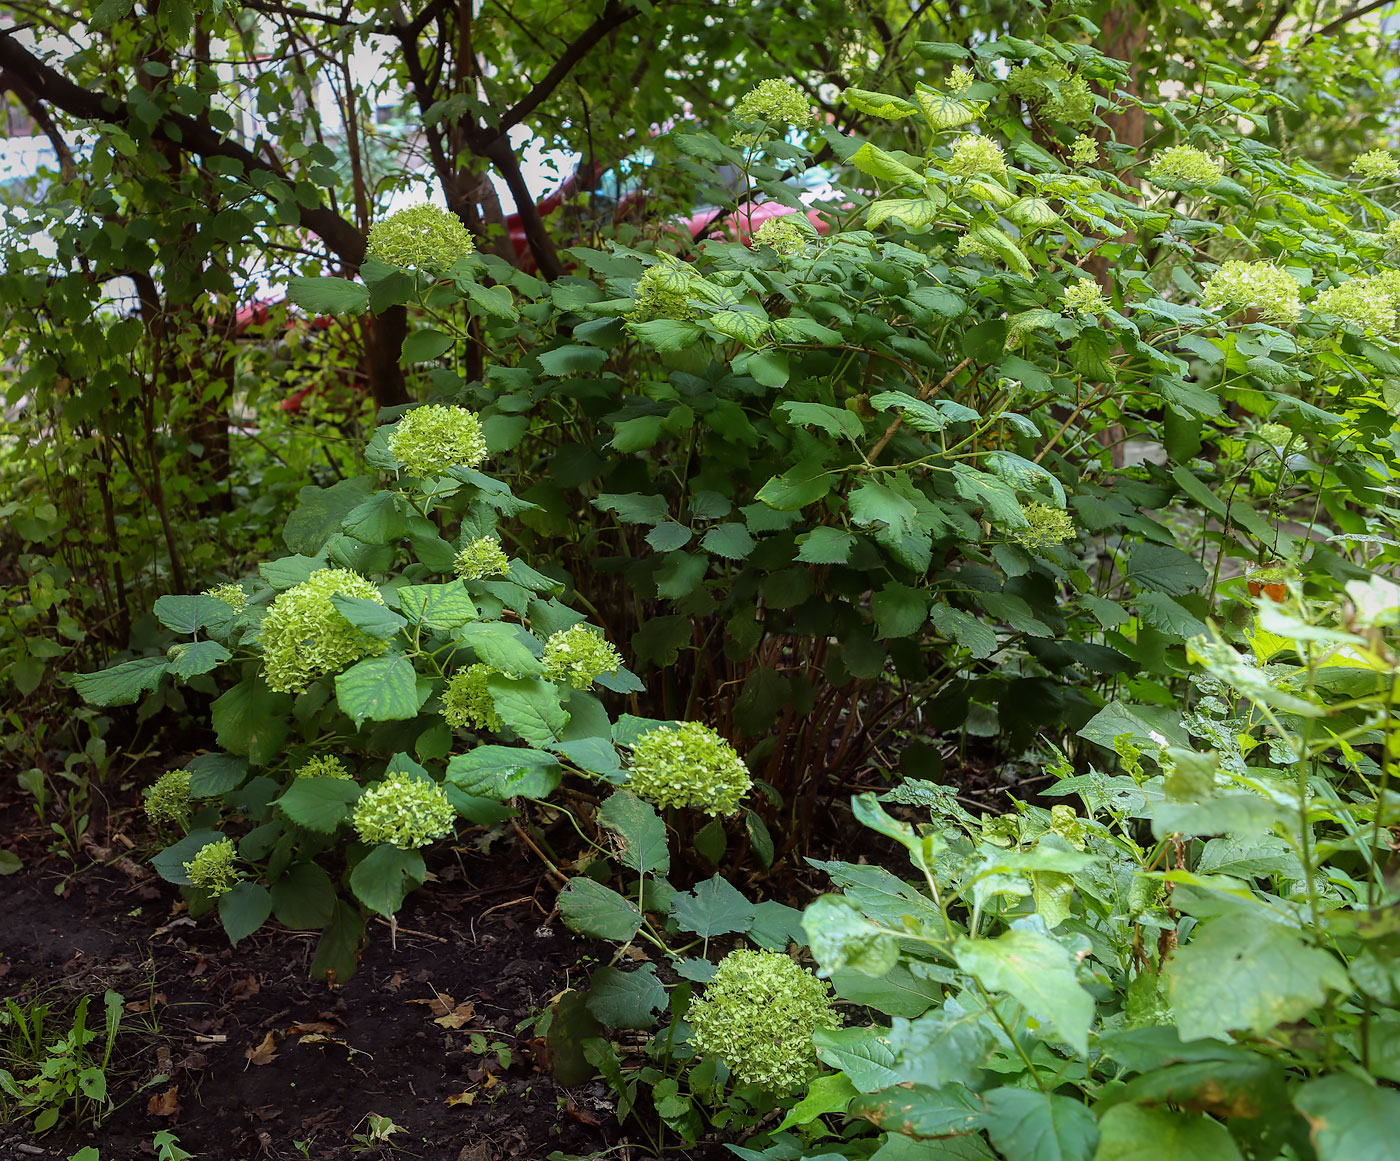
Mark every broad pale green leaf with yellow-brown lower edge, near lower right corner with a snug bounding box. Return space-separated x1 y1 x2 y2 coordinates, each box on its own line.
1165 915 1351 1041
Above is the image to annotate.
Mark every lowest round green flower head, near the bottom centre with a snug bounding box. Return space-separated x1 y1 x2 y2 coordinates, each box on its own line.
686 950 841 1092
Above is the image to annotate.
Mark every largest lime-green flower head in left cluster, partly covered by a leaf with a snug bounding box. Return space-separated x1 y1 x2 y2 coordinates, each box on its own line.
260 569 389 693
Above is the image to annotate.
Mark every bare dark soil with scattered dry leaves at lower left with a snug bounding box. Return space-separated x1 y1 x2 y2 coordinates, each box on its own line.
0 779 683 1161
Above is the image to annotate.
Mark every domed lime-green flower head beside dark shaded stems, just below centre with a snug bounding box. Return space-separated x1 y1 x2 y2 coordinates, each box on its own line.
627 721 753 815
